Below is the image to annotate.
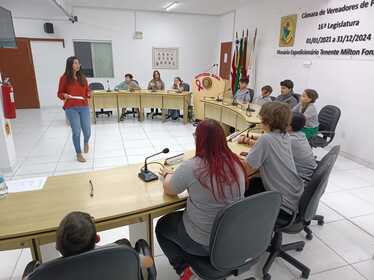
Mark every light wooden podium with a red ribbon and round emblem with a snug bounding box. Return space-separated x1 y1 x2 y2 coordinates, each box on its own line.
192 73 229 120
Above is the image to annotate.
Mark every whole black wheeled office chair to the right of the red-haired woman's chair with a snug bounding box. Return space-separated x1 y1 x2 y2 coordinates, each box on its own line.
263 146 340 280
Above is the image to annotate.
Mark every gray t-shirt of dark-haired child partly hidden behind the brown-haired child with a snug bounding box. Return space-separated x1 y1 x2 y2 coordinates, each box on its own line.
290 131 317 181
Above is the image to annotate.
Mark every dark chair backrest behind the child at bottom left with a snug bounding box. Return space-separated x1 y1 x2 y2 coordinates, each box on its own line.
26 244 141 280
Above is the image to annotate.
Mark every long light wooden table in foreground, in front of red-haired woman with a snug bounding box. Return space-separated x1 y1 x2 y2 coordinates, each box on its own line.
0 143 248 261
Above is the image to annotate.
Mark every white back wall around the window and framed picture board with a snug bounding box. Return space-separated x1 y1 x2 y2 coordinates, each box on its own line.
8 8 219 105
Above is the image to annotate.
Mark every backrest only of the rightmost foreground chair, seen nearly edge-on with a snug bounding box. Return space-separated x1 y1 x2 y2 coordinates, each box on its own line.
299 146 340 222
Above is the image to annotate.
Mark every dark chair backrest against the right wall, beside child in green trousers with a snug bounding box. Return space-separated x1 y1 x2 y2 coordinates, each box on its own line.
318 105 341 138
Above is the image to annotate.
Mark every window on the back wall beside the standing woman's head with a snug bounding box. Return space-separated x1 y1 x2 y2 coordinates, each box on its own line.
73 41 114 78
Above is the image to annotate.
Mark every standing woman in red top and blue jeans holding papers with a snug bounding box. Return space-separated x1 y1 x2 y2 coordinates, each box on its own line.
57 56 91 162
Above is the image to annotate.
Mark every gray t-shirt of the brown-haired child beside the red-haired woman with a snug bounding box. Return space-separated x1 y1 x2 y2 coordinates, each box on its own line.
247 132 304 212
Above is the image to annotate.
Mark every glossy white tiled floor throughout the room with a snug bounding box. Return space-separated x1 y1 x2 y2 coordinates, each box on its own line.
0 109 374 280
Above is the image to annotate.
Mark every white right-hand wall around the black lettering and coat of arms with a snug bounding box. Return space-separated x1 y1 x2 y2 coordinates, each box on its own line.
226 0 374 166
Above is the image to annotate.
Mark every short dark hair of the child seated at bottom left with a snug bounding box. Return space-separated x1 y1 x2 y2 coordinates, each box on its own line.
56 212 96 257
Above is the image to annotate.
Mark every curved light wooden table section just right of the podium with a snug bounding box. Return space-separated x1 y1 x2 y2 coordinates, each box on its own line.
201 99 261 131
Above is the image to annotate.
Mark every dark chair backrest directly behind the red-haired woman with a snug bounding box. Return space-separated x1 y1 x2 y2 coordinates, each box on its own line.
210 192 282 271
